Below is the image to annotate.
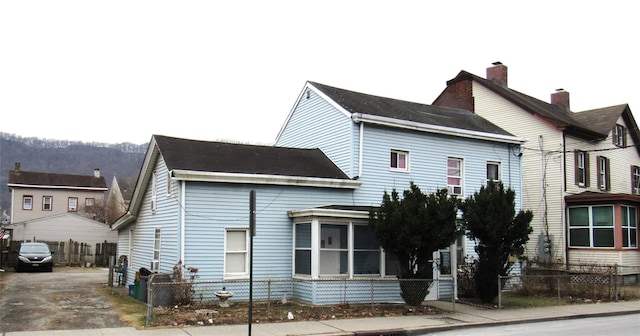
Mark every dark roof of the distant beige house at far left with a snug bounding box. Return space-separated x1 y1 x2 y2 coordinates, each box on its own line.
9 170 107 189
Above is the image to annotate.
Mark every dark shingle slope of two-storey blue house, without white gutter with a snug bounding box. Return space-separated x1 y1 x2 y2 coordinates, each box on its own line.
309 82 511 135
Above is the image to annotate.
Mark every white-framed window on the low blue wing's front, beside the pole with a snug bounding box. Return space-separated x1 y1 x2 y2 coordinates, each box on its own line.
224 228 249 279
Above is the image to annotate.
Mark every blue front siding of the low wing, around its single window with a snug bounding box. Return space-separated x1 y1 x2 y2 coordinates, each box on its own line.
185 182 351 280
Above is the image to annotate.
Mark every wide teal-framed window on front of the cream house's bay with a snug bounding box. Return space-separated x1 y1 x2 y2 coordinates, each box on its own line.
569 206 614 247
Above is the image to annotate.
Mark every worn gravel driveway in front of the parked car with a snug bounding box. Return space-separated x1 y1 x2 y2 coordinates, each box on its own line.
0 267 126 332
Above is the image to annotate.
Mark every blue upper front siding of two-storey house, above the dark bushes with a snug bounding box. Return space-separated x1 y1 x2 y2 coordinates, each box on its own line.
355 125 520 205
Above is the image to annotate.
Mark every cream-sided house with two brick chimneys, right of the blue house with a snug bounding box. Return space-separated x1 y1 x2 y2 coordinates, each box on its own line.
433 62 640 281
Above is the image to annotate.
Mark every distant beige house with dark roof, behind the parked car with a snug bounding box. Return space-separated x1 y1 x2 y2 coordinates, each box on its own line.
7 163 107 223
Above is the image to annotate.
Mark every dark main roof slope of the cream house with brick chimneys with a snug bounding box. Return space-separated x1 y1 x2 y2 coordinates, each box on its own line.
436 70 608 140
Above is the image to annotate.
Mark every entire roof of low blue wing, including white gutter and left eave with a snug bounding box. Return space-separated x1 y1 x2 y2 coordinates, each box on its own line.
112 135 362 230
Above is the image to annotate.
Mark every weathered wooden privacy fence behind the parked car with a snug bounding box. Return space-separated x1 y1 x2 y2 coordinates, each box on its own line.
3 239 118 267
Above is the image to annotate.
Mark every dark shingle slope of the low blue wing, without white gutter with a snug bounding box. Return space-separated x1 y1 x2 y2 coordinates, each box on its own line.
154 135 349 179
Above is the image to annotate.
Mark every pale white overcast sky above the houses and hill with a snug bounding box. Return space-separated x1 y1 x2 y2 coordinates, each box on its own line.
0 0 640 144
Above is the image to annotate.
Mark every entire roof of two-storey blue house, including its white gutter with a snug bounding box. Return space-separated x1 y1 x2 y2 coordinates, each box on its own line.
308 82 521 142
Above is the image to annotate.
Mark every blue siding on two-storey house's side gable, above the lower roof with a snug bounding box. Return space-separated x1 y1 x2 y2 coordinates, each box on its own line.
275 91 356 176
